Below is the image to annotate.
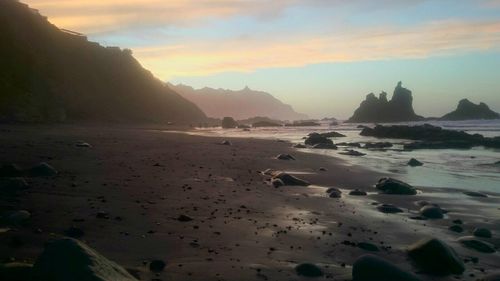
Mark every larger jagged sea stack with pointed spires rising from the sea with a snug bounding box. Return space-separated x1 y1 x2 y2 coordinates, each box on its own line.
348 82 423 123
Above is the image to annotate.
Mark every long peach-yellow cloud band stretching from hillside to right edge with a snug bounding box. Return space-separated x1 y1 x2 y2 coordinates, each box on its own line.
134 21 500 78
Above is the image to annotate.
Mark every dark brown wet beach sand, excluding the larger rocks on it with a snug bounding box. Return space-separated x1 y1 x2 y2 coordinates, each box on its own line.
0 126 500 280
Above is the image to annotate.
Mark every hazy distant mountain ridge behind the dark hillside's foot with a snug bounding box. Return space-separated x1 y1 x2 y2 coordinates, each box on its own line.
168 83 308 120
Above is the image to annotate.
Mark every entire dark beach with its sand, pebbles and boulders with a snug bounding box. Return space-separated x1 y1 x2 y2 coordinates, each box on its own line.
0 125 500 280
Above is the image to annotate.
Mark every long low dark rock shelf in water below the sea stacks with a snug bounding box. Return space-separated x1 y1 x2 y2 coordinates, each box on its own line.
360 124 500 150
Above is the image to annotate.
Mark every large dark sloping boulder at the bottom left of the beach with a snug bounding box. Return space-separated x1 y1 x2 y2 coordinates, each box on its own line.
33 238 137 281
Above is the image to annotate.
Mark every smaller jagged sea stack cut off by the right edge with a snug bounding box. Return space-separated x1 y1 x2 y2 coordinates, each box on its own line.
441 99 500 121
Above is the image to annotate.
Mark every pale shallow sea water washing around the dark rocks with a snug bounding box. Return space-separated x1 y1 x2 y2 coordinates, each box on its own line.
191 120 500 192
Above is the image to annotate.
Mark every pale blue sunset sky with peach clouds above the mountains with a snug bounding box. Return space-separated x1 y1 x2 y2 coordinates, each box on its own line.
24 0 500 118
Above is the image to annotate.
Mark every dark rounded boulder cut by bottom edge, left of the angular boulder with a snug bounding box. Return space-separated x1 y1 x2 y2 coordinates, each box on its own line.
352 255 420 281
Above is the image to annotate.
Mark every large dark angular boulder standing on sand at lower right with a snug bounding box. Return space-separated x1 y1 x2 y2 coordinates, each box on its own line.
408 238 465 275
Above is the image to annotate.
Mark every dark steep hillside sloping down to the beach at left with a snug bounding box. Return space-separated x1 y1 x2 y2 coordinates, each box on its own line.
0 0 206 122
